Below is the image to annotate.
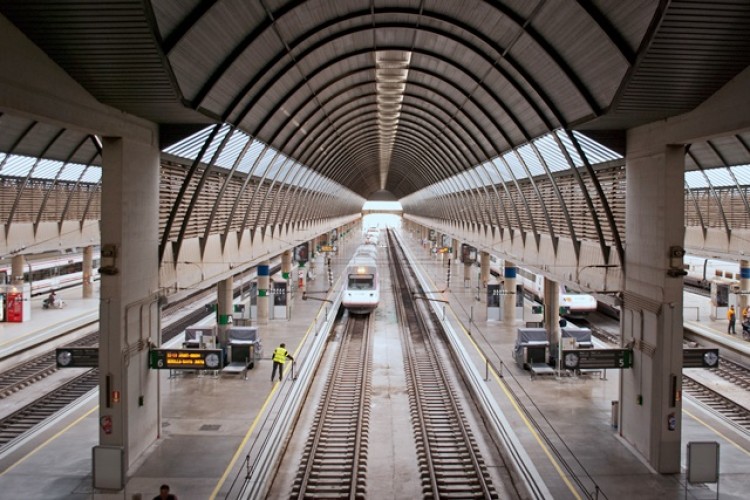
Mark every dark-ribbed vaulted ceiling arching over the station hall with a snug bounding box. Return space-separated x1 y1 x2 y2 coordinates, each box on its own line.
0 0 750 199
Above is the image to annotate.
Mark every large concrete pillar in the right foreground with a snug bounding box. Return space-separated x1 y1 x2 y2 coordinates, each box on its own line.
619 140 685 474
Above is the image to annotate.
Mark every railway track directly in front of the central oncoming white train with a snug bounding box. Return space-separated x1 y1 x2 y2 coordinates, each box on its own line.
291 315 372 499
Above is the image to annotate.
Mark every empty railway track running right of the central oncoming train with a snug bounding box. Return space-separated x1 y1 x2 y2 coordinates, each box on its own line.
391 232 499 499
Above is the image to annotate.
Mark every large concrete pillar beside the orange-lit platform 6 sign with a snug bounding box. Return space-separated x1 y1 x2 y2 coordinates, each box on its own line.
94 137 161 472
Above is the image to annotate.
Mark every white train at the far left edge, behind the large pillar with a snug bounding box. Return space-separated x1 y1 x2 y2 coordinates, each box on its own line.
0 251 100 295
